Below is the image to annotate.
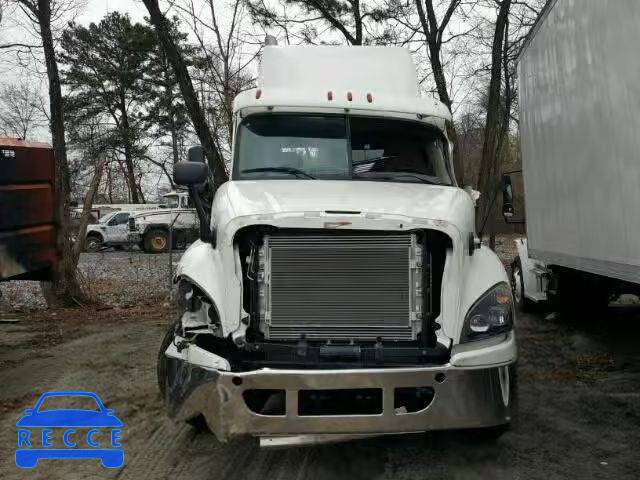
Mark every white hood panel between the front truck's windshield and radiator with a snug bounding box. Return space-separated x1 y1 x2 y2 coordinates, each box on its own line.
218 180 474 231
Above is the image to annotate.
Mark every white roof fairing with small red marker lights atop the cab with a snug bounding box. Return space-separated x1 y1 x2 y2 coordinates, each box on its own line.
234 46 451 120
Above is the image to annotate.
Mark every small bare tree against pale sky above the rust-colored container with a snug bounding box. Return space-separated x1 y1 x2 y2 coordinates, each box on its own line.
0 82 46 139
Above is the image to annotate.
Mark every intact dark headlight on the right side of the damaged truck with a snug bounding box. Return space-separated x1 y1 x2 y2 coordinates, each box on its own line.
460 282 513 343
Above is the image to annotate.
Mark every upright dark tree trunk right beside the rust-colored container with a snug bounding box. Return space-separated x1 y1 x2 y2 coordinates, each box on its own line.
34 0 84 307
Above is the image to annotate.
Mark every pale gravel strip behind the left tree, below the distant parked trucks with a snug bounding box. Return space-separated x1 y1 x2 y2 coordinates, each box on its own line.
0 250 181 312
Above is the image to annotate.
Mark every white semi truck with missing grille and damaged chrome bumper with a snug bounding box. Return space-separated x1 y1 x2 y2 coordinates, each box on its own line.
158 46 517 445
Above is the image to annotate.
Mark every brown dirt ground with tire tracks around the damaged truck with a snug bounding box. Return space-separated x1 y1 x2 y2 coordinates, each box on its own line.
0 262 640 480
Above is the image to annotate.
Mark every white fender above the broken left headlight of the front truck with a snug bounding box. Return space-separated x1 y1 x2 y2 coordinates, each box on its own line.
174 240 229 335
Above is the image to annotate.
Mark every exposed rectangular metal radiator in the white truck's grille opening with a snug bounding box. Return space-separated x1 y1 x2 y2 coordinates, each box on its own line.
260 234 422 340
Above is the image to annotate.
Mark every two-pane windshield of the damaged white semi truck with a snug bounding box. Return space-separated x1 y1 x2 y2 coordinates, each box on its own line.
233 114 451 185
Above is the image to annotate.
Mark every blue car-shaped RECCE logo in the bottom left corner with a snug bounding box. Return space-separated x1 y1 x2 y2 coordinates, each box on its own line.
15 391 124 468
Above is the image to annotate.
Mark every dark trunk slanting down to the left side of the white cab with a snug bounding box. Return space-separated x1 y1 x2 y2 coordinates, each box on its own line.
143 0 227 190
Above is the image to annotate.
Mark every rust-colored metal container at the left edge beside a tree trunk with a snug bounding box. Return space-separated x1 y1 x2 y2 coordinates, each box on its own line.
0 137 59 281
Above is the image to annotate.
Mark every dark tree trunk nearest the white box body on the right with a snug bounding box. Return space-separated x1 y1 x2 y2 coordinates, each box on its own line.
476 0 511 231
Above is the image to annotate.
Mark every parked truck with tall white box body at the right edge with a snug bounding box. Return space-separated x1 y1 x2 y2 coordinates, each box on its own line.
504 0 640 316
